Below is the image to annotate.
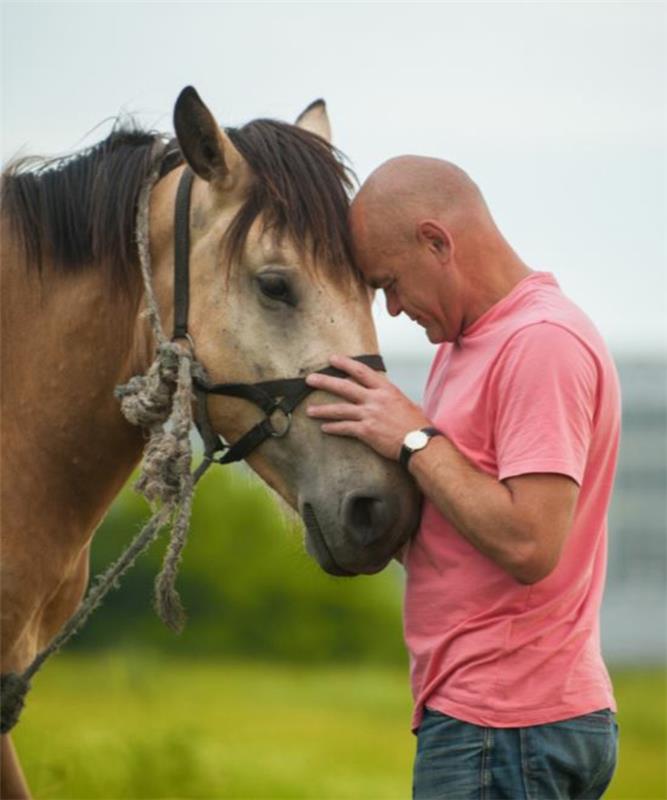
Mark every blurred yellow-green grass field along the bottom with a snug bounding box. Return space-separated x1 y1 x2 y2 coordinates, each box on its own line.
15 653 667 800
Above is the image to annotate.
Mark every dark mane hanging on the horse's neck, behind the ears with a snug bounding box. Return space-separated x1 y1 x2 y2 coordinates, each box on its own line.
2 123 170 285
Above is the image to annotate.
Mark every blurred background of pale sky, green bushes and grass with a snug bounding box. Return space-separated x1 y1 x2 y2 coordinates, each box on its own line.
1 2 667 798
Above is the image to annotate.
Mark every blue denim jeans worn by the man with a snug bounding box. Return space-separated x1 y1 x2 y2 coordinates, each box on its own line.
413 708 618 800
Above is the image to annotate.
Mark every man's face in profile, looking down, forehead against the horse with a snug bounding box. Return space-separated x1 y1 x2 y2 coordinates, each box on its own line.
352 205 459 344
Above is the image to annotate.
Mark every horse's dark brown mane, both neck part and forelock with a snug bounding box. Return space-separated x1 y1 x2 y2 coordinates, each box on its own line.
2 112 356 285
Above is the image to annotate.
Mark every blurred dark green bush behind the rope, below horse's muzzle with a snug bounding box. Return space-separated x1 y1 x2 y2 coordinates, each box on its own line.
72 462 405 663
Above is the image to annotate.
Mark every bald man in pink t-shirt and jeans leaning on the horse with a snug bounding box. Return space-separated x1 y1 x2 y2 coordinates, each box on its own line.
308 156 620 800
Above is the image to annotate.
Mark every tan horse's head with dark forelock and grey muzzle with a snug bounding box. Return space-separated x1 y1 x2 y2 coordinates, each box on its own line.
151 89 419 575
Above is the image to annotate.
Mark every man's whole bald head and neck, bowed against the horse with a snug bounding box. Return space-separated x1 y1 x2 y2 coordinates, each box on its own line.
350 156 530 343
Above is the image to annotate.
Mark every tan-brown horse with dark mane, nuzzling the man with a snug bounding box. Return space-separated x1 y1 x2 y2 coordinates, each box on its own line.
0 87 419 798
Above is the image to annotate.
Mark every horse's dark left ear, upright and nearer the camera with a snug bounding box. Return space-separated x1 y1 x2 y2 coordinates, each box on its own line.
174 86 243 183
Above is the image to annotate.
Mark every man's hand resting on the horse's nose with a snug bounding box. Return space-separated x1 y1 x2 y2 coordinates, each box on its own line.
306 356 432 459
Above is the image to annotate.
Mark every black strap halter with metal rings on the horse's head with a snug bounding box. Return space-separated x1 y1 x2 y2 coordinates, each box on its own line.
172 166 385 464
